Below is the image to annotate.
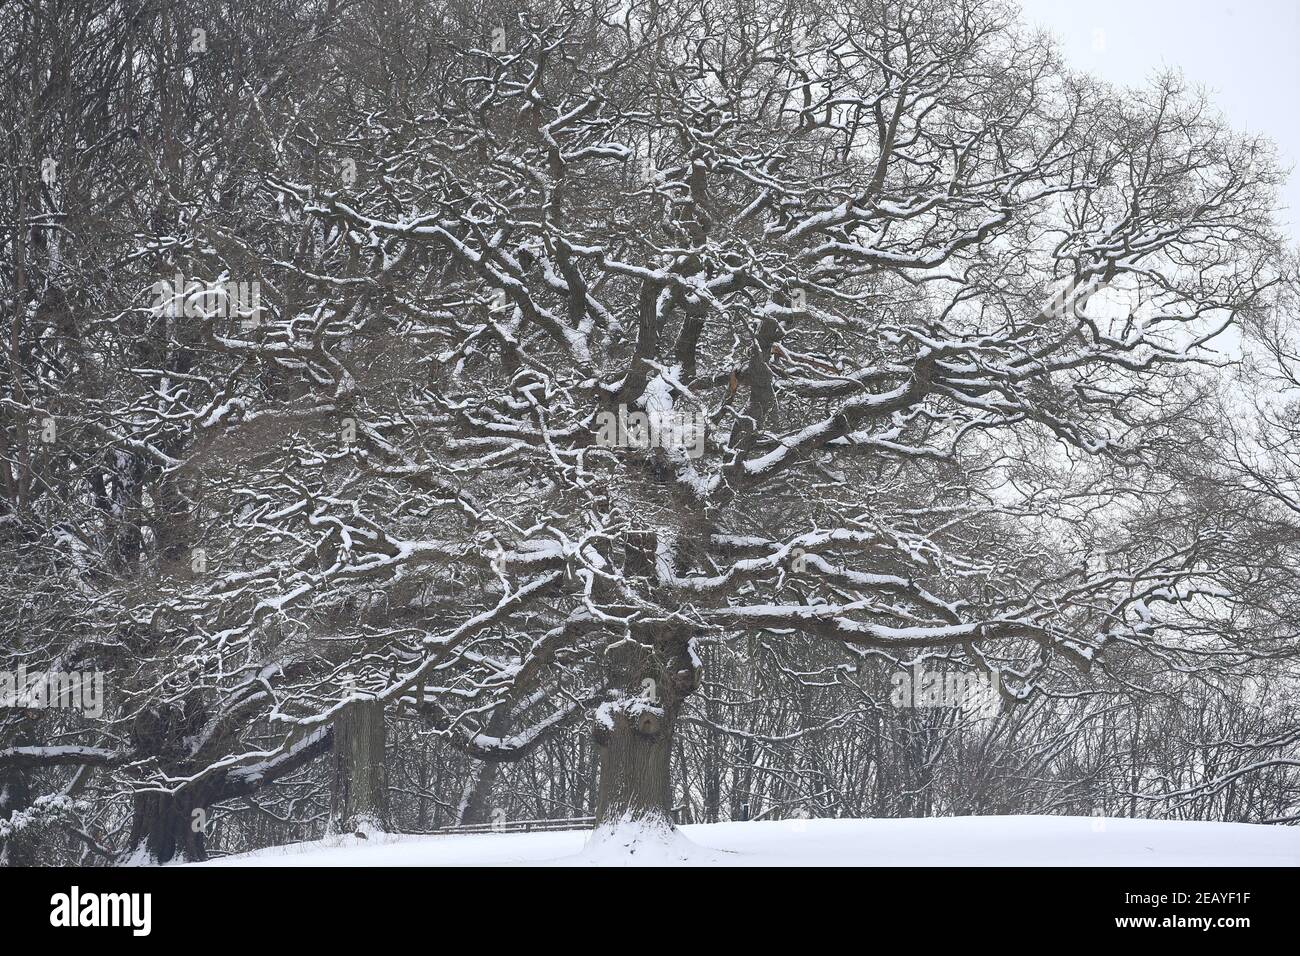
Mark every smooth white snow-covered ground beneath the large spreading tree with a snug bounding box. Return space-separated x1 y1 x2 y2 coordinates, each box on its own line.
195 817 1300 866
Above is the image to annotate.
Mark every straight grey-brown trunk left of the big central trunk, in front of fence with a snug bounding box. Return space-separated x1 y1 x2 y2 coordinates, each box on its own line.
330 700 389 832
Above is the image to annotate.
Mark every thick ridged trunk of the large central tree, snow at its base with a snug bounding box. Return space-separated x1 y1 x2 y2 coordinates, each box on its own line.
593 626 699 830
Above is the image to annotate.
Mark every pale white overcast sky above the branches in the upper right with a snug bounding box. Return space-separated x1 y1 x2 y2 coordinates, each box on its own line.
1019 0 1300 238
